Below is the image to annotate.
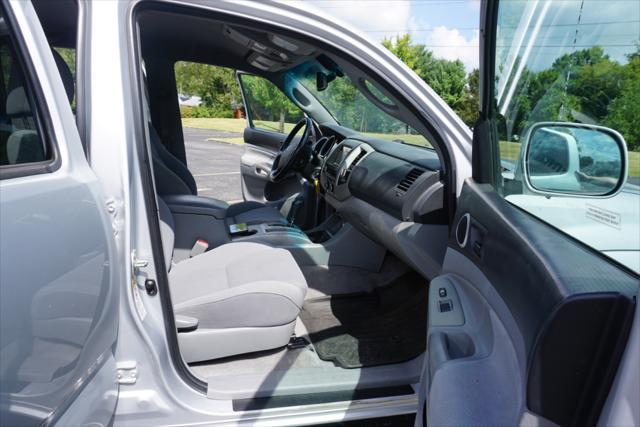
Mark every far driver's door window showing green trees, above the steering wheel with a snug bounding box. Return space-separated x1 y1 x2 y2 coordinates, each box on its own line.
242 74 304 134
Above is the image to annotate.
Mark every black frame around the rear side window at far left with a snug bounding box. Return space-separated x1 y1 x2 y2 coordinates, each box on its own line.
0 2 61 181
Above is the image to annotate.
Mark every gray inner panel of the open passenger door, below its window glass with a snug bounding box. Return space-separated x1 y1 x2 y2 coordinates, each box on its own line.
421 180 638 425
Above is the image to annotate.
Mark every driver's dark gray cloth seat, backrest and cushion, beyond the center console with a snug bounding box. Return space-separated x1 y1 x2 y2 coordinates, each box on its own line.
149 124 286 224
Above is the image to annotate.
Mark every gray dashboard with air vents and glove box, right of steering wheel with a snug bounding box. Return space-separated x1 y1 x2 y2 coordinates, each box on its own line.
317 127 449 278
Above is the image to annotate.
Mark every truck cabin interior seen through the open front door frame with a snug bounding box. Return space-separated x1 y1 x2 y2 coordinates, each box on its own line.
134 5 449 404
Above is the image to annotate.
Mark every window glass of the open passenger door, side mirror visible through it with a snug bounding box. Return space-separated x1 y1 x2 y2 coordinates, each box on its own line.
494 0 640 270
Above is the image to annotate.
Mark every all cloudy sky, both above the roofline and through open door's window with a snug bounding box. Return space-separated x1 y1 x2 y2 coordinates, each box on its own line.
304 0 640 71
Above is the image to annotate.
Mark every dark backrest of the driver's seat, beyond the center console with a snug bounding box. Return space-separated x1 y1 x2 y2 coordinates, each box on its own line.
149 123 198 196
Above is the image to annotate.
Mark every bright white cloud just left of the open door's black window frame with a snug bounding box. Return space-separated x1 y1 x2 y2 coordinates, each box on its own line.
425 26 480 71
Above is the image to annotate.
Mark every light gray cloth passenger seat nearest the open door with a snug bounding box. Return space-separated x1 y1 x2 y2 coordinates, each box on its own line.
158 199 307 362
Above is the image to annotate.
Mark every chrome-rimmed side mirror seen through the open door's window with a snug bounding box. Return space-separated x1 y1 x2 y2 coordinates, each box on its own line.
523 122 627 197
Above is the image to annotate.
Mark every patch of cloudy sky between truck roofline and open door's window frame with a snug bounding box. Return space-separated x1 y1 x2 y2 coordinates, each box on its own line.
305 0 480 71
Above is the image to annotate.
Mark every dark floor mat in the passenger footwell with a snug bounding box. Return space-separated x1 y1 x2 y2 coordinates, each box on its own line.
300 272 428 368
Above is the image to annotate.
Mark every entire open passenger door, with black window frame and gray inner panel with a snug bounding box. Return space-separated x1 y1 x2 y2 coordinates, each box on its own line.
416 1 639 426
